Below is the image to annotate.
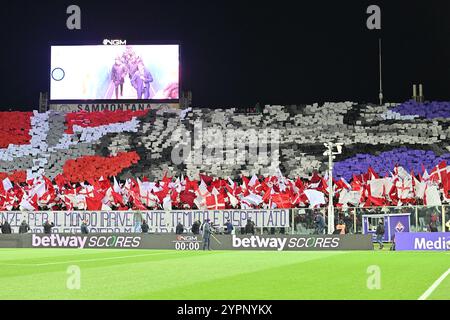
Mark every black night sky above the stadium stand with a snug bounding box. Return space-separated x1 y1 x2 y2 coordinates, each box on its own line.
0 0 450 110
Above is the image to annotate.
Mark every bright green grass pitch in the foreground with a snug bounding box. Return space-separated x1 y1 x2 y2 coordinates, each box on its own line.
0 249 450 300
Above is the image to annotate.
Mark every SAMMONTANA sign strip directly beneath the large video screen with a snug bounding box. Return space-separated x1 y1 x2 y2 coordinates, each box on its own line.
49 103 180 112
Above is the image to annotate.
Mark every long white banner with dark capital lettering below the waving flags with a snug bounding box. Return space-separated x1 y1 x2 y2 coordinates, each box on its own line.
0 209 289 234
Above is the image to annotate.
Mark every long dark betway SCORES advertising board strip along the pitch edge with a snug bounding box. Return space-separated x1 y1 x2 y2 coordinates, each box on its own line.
0 233 373 251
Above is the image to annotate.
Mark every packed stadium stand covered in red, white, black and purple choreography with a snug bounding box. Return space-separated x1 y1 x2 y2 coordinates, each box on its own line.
0 101 450 210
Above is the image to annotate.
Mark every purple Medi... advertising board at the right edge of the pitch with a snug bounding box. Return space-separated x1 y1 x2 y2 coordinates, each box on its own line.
395 232 450 251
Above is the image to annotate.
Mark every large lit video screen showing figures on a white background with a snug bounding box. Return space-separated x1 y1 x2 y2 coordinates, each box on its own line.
50 45 180 100
